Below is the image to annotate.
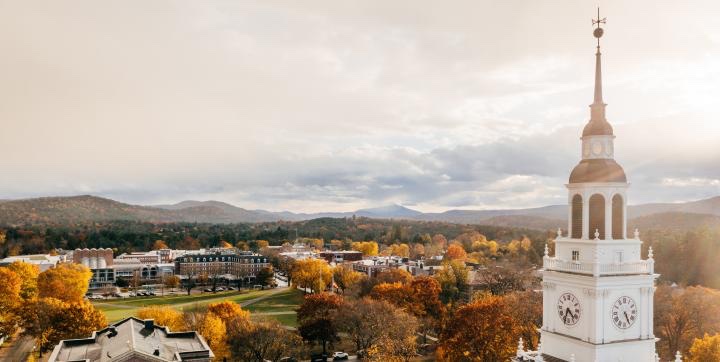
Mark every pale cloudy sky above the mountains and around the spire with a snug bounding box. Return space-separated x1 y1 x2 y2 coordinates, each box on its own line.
0 0 720 212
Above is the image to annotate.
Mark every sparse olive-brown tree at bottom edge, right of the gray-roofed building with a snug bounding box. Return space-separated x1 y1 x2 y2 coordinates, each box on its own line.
227 319 302 362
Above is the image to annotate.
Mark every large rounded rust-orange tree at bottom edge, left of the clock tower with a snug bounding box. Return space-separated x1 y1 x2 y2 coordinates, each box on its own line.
437 296 518 362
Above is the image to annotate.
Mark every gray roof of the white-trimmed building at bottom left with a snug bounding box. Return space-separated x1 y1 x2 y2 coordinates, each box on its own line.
49 317 214 362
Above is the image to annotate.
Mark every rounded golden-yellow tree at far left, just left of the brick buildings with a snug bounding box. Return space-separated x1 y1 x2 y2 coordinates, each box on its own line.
38 264 92 303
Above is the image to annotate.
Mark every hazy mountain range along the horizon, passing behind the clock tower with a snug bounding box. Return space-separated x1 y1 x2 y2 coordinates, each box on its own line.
0 195 720 230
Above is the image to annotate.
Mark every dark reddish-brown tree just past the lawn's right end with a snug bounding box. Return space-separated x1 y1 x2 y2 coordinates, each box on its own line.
297 293 343 354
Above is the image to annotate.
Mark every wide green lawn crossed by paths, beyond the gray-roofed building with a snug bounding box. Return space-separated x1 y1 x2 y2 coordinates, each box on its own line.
93 289 302 327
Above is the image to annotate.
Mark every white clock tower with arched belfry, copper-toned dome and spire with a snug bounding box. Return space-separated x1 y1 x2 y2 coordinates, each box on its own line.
516 9 658 362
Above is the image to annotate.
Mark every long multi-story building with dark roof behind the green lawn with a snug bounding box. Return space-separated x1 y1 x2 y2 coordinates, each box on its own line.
175 248 270 282
